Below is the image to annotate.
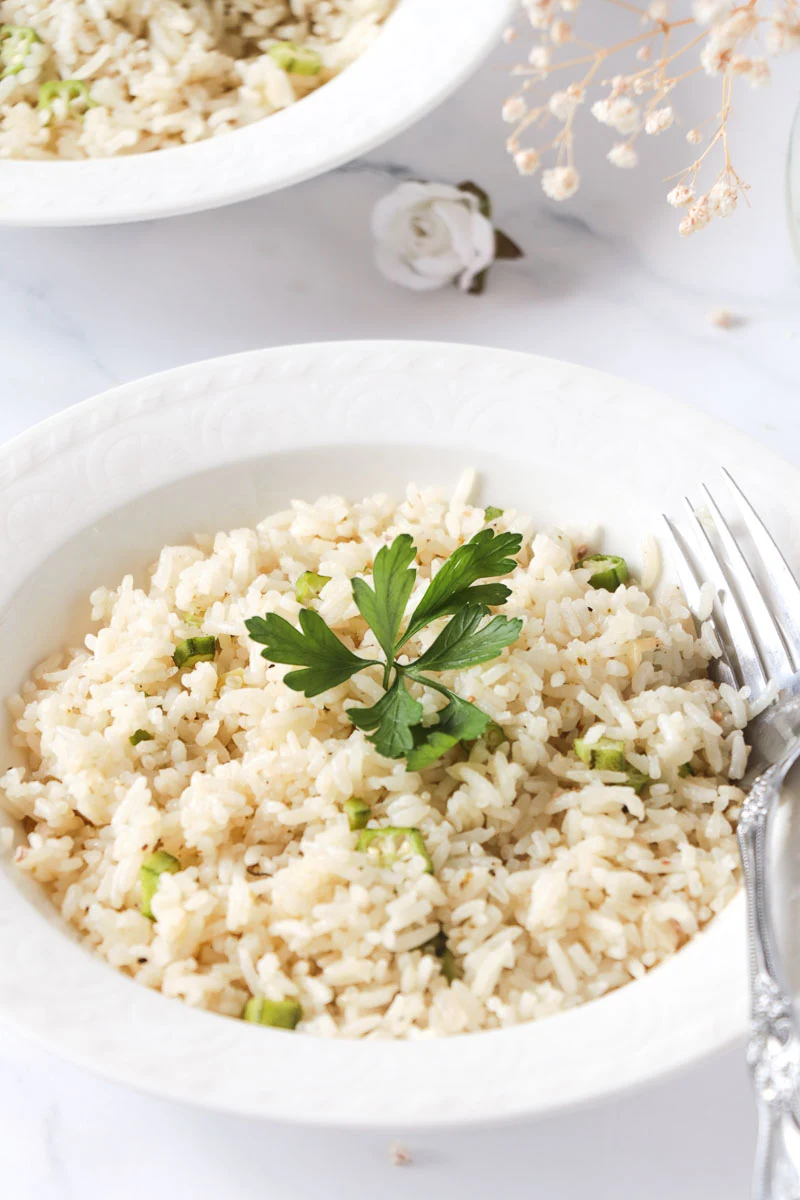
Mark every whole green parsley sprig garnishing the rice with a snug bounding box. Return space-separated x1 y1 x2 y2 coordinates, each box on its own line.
246 529 522 770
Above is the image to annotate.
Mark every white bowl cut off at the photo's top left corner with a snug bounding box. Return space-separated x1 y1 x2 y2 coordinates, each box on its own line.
0 0 513 226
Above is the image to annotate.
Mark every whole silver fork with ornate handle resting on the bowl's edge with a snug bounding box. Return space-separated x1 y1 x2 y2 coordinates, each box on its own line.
663 472 800 1200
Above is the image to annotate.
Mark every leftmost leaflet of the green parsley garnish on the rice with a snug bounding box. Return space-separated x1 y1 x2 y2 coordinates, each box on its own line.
245 608 375 697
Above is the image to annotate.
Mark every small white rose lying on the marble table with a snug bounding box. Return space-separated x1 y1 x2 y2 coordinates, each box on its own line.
372 184 495 292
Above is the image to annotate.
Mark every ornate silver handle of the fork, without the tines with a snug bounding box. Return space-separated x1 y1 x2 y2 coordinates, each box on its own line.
738 763 800 1200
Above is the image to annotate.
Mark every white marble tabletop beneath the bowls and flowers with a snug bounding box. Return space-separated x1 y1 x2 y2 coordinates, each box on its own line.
0 25 800 1200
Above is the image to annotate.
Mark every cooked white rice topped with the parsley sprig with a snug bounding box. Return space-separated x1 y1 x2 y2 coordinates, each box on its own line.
0 486 747 1037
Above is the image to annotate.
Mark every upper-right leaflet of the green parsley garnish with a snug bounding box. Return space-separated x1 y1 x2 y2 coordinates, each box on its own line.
396 529 522 652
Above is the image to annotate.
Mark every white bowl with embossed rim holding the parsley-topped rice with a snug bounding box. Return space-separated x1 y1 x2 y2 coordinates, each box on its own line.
0 343 800 1129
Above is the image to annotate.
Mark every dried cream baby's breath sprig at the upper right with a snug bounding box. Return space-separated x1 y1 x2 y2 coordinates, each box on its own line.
503 0 800 236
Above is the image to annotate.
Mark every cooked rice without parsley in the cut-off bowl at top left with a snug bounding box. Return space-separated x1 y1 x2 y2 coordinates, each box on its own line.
0 0 395 158
